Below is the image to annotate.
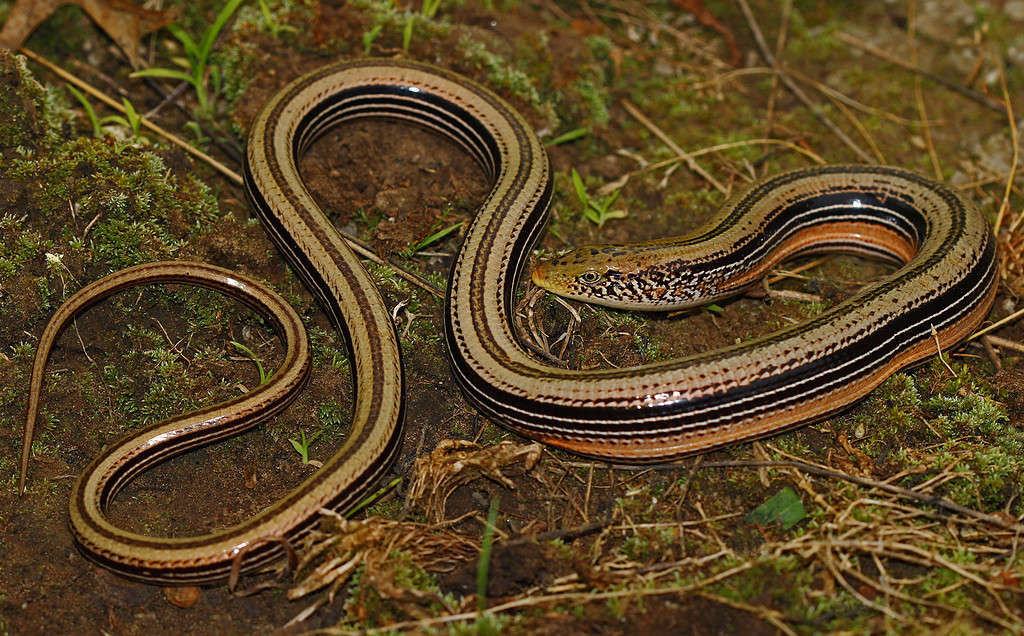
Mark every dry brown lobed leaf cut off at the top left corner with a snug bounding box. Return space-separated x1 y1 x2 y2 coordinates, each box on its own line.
0 0 180 69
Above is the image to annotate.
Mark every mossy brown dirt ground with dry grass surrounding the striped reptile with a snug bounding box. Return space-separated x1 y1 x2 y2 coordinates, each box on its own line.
0 0 1024 634
